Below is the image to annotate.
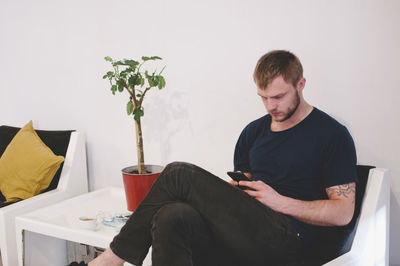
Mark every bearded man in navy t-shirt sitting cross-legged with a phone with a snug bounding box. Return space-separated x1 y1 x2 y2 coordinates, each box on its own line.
89 50 356 266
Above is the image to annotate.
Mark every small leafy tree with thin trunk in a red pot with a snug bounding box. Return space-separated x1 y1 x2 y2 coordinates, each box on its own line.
103 56 165 211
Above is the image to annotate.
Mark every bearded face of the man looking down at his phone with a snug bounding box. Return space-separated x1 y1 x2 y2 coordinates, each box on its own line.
257 76 300 122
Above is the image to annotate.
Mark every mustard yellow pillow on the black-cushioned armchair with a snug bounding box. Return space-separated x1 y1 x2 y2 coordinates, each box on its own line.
0 121 64 202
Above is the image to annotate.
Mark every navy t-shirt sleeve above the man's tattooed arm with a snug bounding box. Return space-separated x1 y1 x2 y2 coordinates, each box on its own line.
322 126 357 188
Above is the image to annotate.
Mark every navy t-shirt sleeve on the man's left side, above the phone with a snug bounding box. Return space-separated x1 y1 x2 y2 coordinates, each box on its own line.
233 127 250 172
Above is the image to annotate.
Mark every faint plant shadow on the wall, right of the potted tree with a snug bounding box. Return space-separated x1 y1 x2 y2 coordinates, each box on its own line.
144 91 193 162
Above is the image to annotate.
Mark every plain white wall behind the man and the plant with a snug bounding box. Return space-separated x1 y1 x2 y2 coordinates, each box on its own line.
0 0 400 265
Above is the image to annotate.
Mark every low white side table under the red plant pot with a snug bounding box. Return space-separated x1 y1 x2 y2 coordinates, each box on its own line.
16 187 150 266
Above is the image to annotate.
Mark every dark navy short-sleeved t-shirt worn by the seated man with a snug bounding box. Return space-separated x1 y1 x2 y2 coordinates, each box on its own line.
234 107 357 242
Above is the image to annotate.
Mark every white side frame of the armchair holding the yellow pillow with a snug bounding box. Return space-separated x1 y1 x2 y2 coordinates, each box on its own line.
0 131 88 266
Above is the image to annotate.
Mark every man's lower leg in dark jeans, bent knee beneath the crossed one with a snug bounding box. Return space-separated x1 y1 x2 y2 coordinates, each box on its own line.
151 202 219 266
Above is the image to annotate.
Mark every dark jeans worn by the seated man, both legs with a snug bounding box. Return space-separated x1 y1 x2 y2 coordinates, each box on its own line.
110 162 302 266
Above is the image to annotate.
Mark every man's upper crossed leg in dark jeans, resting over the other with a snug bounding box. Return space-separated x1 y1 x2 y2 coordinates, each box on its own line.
110 163 300 265
